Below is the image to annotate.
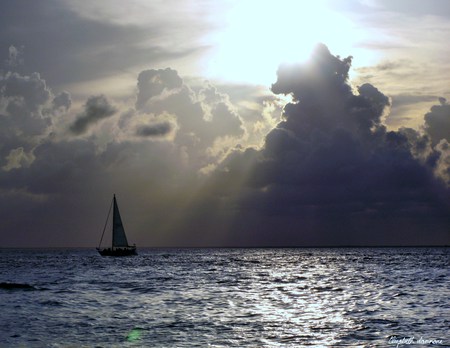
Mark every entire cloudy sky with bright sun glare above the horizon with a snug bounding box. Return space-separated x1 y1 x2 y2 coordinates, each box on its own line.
0 0 450 247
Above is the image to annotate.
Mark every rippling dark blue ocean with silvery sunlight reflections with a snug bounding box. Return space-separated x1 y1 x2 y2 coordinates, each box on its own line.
0 248 450 347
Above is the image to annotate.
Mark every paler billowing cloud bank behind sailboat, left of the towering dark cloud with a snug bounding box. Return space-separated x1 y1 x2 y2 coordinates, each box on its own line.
0 63 258 245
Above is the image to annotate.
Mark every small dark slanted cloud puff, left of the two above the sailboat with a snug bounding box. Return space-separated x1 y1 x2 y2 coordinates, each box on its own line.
70 95 117 135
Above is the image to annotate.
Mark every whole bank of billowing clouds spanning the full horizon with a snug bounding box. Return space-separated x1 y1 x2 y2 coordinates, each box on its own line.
0 46 450 246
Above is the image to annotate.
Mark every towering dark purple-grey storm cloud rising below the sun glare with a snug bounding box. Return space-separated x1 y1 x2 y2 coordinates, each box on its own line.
197 46 450 245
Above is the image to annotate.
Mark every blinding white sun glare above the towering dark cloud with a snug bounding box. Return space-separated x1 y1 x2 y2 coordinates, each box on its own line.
207 0 370 85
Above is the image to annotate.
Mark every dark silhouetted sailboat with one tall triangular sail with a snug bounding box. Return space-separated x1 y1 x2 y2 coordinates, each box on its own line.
97 195 137 256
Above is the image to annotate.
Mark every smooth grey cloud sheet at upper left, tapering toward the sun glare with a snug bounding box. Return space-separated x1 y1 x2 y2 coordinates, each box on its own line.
0 0 210 86
